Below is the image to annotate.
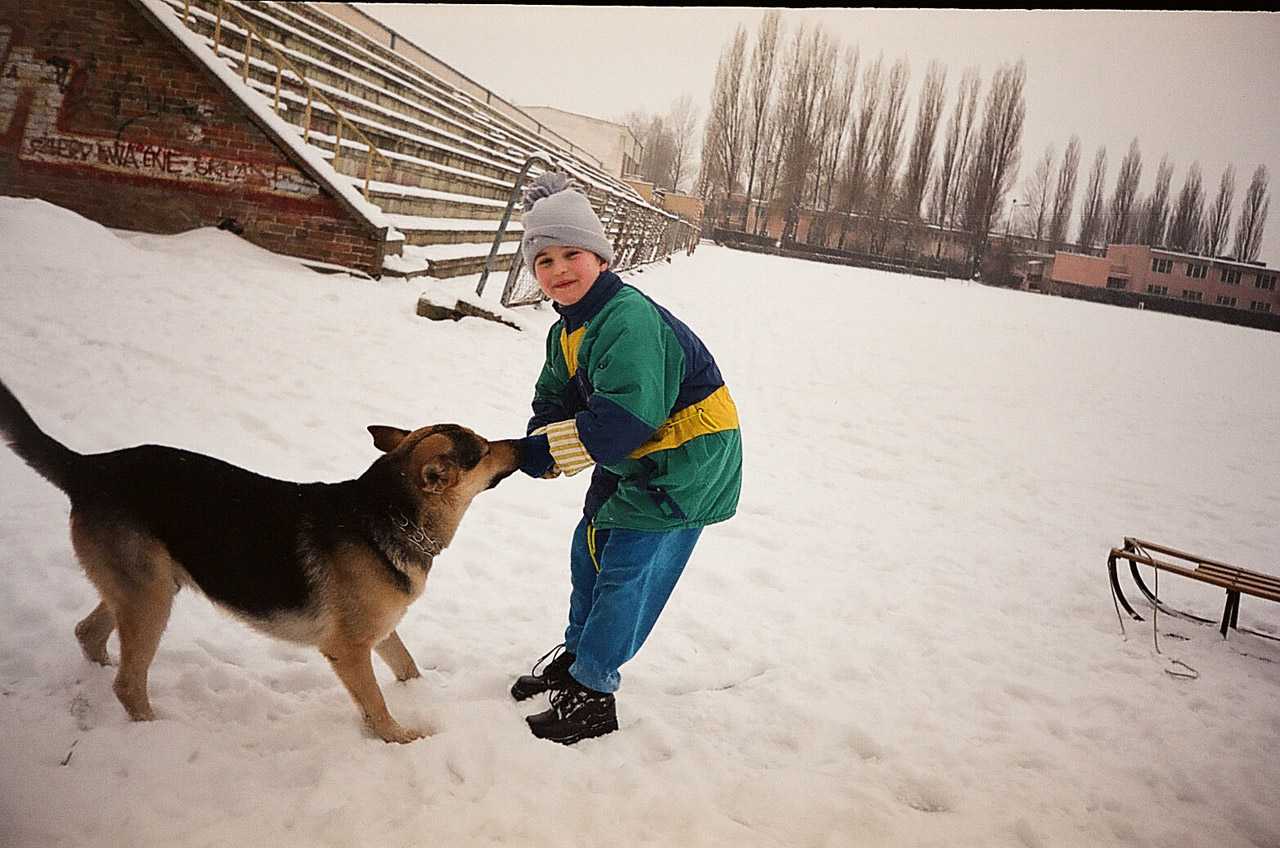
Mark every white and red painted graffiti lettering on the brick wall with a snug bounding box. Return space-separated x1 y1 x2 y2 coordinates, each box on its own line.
0 26 320 199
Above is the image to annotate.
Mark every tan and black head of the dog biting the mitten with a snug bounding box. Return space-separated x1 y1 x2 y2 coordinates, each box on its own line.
369 424 521 505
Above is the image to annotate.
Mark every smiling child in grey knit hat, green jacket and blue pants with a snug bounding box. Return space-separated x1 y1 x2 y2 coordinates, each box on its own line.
511 173 742 744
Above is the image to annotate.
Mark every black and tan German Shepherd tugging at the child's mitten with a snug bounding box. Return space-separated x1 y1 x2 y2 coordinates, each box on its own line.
0 383 521 742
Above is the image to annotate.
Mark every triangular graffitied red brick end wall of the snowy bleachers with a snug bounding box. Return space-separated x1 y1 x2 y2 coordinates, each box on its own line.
0 0 385 274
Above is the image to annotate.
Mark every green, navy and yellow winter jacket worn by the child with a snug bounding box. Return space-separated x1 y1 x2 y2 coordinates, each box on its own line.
522 270 742 530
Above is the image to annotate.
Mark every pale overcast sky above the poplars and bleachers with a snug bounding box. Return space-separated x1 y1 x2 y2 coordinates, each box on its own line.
356 4 1280 268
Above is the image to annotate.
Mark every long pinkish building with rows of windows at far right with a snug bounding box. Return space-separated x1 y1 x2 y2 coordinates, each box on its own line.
1021 245 1280 314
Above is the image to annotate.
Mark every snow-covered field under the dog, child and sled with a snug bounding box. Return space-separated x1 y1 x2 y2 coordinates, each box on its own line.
0 199 1280 848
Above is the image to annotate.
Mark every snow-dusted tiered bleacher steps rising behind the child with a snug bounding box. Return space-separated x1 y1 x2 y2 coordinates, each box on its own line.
156 0 666 285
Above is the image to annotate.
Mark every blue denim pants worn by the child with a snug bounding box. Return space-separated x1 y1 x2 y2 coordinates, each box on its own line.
564 518 703 692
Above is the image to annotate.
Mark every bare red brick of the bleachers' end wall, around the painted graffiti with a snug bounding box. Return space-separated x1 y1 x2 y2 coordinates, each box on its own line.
0 0 381 274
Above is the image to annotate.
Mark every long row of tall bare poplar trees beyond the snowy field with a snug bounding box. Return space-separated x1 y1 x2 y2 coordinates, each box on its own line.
700 10 1270 261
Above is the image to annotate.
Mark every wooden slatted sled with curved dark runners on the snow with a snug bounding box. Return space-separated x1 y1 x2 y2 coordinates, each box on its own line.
1107 537 1280 640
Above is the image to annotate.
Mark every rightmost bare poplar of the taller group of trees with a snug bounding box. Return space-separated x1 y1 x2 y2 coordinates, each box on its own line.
965 59 1027 268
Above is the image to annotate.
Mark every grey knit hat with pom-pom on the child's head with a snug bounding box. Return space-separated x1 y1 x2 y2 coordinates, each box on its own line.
520 170 613 270
